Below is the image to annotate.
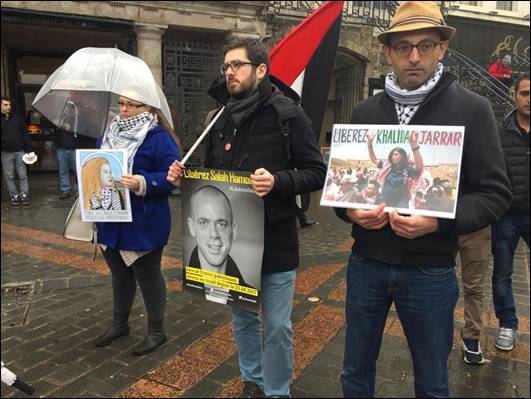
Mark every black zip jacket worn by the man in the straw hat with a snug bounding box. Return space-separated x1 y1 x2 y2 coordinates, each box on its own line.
336 73 511 267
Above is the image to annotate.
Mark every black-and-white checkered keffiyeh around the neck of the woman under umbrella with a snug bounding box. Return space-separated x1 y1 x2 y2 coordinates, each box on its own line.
101 112 158 173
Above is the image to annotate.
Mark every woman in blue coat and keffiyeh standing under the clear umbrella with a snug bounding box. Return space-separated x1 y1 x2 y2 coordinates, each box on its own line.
93 92 179 356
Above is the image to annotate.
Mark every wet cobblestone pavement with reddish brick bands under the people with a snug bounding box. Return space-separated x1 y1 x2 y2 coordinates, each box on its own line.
1 175 529 397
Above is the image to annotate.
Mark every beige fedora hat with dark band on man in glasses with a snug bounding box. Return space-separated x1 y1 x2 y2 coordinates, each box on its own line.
377 1 455 44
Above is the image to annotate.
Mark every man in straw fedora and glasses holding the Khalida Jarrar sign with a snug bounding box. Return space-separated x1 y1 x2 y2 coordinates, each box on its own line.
336 1 511 397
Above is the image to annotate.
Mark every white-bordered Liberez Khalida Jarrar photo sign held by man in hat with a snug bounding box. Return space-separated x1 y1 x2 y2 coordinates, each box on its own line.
321 125 465 219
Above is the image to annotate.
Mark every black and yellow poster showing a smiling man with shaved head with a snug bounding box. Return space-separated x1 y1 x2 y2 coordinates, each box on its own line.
181 169 264 312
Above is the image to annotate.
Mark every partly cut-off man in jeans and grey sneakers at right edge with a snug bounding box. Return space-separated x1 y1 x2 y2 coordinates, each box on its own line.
492 72 530 351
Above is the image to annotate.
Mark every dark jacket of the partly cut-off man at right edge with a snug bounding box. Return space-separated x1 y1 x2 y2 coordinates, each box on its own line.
498 111 529 215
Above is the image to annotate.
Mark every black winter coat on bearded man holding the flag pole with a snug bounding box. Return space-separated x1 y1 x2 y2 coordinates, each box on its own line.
205 77 326 273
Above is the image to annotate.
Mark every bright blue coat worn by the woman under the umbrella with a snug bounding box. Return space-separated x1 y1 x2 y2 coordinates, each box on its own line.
96 126 179 251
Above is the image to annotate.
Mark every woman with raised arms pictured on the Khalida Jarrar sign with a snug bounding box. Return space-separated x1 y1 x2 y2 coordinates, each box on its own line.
367 131 424 208
